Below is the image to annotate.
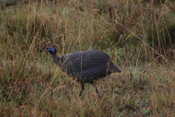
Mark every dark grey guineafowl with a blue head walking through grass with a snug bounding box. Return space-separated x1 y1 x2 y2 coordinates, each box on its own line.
47 47 121 96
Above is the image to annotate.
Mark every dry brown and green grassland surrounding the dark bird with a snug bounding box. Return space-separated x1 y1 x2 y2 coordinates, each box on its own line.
0 0 175 117
